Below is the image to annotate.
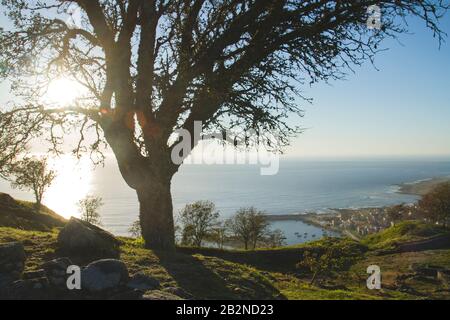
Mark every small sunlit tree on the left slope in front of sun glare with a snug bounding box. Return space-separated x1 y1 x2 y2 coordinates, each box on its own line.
11 157 56 212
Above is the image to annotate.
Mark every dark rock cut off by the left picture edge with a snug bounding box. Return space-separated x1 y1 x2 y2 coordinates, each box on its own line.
0 242 26 276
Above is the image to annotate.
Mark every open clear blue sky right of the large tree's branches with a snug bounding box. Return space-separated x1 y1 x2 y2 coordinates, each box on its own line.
0 11 450 158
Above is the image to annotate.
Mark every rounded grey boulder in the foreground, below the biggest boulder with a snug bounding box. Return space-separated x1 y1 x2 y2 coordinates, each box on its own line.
81 259 129 292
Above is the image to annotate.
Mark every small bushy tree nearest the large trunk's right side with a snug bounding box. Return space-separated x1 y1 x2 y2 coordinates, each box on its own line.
180 201 219 247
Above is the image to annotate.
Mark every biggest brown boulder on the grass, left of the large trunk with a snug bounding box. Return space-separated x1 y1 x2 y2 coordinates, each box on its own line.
58 218 120 257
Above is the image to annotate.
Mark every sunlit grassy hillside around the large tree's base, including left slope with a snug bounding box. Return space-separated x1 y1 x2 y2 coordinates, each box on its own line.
0 194 450 300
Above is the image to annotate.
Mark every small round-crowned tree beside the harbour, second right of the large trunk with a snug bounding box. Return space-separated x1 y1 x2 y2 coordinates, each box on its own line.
227 207 269 250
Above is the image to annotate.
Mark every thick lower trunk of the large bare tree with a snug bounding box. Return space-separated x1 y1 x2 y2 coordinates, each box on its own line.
137 179 175 251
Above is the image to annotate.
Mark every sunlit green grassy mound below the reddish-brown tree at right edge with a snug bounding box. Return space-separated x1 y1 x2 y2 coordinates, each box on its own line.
361 221 449 250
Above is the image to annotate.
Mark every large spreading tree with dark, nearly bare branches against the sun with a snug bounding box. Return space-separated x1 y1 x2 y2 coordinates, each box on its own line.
0 0 448 250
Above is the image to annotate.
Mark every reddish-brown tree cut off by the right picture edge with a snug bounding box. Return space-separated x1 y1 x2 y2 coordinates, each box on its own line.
419 183 450 227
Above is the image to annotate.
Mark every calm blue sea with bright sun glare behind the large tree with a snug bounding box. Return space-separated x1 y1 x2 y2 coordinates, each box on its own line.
0 157 450 245
